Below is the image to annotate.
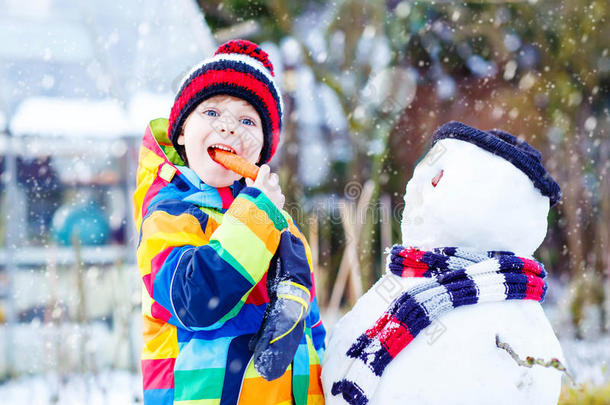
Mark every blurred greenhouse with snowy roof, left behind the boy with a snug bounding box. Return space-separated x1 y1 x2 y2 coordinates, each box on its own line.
0 0 215 377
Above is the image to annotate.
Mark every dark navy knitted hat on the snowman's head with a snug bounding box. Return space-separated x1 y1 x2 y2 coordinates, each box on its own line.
432 121 561 206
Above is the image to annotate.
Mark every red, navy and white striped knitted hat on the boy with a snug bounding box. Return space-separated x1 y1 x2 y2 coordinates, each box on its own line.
167 40 283 164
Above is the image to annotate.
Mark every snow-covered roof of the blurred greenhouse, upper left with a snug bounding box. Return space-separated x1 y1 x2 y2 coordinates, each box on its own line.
0 0 217 138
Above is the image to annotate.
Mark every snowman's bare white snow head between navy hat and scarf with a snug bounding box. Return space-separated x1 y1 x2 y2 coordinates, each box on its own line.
401 139 549 252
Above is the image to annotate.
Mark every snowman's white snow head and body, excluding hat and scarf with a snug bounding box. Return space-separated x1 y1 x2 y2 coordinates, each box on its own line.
322 139 565 405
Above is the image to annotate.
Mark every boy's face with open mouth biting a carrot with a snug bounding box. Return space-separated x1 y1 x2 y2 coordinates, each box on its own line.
178 95 263 187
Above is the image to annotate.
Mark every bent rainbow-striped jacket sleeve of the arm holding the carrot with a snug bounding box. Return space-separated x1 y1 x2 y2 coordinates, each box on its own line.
137 188 287 329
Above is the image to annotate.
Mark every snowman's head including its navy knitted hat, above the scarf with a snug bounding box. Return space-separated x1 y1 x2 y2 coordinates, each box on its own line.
401 122 561 256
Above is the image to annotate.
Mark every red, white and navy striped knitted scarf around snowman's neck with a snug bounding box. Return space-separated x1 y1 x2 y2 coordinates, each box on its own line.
331 245 547 405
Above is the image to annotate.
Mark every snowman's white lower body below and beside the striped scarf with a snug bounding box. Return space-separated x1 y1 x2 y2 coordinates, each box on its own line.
322 286 562 405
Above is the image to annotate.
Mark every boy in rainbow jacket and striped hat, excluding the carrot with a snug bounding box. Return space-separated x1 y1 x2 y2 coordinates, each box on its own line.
134 40 325 405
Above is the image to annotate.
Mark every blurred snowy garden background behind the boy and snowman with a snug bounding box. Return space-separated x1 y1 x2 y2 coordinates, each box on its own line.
0 0 610 404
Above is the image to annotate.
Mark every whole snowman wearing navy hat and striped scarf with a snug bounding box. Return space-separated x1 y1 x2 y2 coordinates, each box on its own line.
322 122 565 405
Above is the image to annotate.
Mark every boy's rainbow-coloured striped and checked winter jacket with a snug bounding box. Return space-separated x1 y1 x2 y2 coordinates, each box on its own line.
133 119 325 405
